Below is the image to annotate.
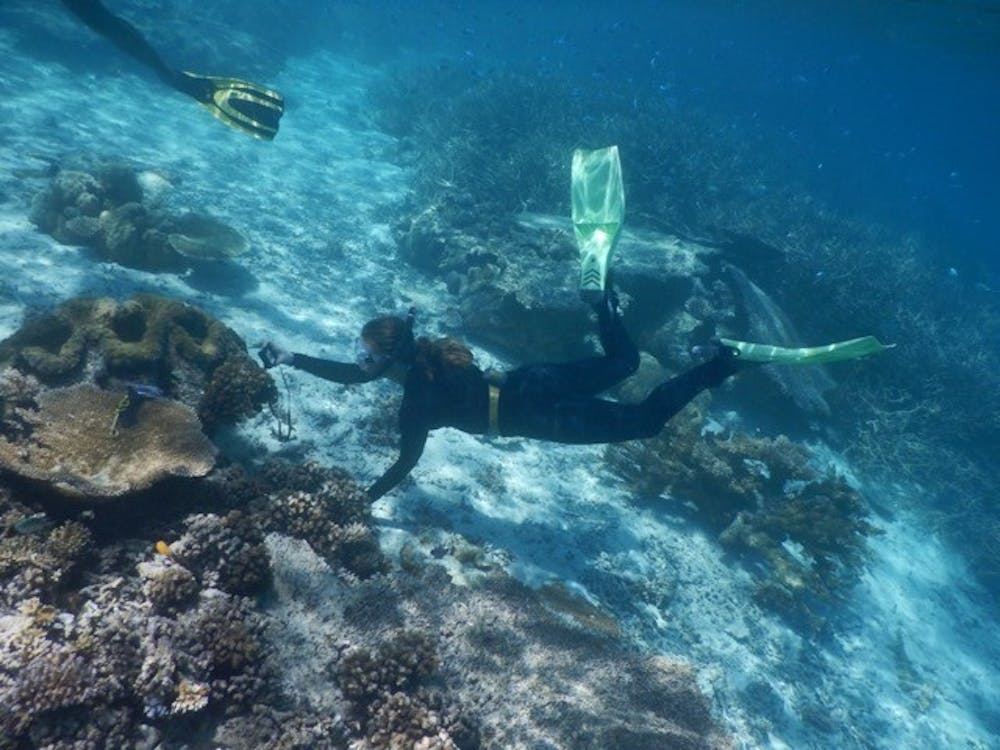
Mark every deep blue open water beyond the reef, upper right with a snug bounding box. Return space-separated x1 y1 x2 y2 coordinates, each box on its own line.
317 0 1000 274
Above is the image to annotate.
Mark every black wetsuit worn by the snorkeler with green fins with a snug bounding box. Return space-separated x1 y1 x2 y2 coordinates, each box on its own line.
292 305 737 500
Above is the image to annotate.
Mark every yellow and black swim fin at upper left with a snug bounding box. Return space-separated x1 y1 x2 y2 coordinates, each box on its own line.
177 71 285 141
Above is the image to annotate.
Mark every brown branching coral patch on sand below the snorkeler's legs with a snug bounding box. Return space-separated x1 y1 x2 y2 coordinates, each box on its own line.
607 396 877 628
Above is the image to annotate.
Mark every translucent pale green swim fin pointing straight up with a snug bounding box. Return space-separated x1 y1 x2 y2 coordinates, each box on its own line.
571 146 625 303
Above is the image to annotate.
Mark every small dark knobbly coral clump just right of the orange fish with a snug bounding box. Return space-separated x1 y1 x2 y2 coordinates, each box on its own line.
170 511 270 594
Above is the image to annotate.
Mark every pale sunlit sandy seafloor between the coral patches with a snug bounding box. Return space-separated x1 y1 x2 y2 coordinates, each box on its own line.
0 30 1000 749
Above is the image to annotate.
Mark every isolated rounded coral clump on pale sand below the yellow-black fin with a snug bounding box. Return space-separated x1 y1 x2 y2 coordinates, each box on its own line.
31 164 247 271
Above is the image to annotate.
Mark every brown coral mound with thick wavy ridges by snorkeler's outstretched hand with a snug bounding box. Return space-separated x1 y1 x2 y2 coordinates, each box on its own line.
0 295 277 431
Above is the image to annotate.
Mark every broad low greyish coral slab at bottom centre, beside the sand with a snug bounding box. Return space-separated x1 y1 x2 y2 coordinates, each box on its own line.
269 538 729 750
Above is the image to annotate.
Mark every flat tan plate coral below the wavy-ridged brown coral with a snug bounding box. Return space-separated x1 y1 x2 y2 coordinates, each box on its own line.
0 384 215 502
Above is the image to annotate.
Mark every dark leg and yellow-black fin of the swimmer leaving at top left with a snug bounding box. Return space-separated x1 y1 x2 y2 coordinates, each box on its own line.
62 0 285 141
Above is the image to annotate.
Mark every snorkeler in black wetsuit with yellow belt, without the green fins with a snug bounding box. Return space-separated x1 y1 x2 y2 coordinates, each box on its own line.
260 294 744 500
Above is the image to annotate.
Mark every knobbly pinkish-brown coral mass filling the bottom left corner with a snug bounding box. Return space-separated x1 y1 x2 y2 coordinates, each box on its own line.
0 540 284 748
